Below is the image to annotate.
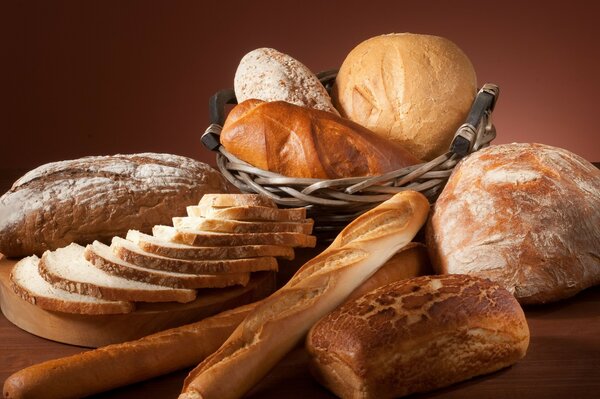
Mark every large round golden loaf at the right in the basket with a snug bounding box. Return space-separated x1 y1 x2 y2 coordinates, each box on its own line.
332 33 477 161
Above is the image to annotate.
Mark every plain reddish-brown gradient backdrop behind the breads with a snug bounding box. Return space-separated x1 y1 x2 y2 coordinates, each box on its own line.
0 0 600 168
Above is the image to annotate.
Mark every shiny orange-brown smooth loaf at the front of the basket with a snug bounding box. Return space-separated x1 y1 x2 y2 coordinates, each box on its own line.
220 100 419 179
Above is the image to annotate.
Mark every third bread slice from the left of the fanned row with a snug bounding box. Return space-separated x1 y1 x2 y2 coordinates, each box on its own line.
83 241 250 288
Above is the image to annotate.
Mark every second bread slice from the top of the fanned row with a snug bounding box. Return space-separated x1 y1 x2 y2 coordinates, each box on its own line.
187 205 306 222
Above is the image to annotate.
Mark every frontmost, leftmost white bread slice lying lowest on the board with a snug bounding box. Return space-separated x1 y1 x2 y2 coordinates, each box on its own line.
10 255 134 314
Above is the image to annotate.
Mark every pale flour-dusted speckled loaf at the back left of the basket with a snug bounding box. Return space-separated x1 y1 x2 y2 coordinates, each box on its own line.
233 48 339 115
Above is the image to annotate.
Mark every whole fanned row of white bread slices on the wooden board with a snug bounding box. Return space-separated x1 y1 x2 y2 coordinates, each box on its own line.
11 194 316 314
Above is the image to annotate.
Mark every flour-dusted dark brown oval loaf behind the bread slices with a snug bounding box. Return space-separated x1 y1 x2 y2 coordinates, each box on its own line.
0 153 232 257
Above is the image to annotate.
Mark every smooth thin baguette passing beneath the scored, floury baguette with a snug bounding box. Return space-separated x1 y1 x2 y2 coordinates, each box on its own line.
4 234 428 399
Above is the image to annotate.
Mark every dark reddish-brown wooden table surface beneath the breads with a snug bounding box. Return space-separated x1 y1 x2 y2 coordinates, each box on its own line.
0 164 600 399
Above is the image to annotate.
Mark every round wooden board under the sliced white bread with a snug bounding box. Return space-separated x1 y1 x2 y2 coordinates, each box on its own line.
0 254 275 348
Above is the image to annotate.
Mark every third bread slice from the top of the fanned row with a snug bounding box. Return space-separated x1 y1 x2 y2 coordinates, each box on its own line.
173 216 314 234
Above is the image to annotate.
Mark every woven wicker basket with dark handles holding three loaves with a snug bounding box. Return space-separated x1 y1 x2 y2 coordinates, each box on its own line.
202 71 499 237
